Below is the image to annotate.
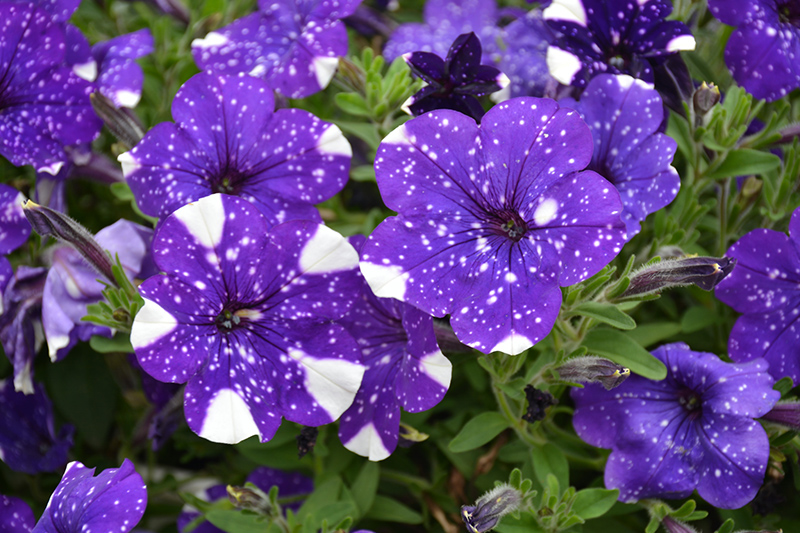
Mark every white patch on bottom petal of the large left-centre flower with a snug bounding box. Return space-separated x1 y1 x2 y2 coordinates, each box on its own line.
198 389 258 444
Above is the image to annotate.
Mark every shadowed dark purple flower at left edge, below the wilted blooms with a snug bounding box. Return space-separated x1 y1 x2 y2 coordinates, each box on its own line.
0 380 75 474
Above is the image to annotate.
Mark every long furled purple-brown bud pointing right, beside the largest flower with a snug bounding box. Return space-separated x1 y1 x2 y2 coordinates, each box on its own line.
620 257 736 298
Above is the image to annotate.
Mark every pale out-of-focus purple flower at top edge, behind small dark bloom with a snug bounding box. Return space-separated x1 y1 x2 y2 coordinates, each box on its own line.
383 0 500 63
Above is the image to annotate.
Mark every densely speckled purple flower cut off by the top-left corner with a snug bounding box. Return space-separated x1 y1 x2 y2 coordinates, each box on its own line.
0 3 102 174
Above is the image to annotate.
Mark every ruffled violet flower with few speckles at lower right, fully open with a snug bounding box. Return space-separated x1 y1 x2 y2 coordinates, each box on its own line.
572 343 780 509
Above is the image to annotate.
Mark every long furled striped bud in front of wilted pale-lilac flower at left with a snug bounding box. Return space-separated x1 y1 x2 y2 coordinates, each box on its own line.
22 200 119 288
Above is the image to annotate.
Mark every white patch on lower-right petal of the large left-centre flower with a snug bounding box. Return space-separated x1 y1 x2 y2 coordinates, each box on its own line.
288 348 365 422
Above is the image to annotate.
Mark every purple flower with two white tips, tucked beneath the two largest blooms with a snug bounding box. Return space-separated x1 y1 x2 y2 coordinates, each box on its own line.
339 236 452 461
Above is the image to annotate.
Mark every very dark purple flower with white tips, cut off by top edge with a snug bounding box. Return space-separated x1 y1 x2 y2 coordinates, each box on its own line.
542 0 695 87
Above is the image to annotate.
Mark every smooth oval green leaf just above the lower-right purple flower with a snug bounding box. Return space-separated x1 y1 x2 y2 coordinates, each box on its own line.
583 329 667 381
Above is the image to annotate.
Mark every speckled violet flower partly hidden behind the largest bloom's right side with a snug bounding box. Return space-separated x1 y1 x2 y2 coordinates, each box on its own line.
565 74 681 239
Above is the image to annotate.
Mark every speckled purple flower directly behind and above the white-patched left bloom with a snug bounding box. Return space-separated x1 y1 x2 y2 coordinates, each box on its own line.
119 73 352 225
